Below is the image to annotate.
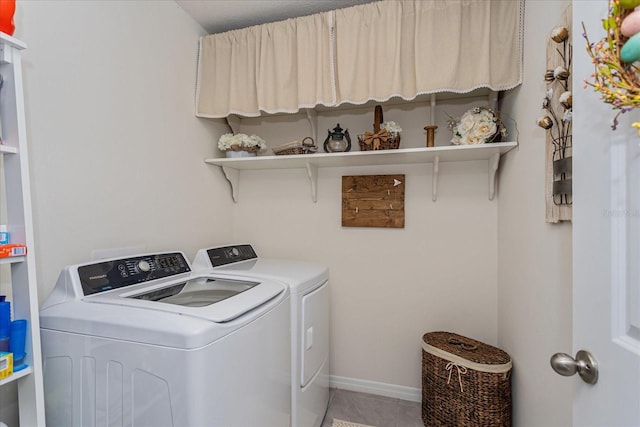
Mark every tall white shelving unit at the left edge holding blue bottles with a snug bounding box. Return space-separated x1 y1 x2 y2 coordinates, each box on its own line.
0 33 45 426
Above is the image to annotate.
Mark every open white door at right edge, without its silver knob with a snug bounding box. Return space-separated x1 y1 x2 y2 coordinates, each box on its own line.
568 0 640 427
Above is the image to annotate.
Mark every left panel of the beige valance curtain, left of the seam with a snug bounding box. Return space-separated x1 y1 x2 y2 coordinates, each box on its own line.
196 13 335 117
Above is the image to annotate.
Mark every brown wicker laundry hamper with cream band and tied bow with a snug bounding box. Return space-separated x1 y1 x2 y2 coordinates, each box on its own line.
422 332 511 427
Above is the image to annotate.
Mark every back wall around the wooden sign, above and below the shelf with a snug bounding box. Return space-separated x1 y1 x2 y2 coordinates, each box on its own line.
233 100 498 394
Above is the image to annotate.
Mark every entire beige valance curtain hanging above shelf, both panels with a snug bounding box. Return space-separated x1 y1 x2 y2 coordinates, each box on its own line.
196 0 523 117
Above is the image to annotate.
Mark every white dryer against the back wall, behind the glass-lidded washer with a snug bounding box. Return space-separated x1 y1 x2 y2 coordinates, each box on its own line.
193 244 329 427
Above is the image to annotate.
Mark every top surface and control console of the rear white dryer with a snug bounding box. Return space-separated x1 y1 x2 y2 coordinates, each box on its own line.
193 244 329 293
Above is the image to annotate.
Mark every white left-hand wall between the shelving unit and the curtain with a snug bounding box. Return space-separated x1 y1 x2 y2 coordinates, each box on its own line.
15 1 232 301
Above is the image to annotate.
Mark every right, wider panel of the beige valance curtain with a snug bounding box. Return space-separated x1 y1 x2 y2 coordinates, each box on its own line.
335 0 522 104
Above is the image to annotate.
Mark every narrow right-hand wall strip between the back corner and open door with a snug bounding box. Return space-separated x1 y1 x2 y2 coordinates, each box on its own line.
498 1 572 427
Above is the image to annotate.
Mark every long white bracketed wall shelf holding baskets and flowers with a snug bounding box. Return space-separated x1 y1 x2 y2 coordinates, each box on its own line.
205 142 518 202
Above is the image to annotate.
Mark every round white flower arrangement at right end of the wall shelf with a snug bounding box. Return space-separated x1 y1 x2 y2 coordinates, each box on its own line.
449 107 507 145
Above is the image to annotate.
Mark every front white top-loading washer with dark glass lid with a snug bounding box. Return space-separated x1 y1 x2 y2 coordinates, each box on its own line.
40 252 291 427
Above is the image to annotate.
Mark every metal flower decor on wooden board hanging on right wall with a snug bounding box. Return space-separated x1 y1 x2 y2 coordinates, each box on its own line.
538 6 573 223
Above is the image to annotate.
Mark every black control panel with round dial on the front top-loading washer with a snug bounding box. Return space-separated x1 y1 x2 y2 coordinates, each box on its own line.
78 252 191 295
